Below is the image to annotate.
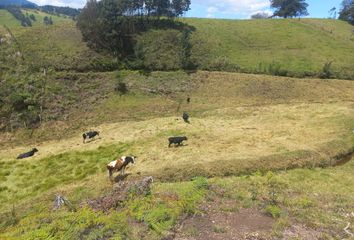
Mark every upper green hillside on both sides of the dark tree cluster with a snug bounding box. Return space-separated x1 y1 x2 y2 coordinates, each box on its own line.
0 10 354 78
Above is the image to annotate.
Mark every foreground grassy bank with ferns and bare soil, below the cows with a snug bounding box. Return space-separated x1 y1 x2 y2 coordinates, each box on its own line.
0 156 354 240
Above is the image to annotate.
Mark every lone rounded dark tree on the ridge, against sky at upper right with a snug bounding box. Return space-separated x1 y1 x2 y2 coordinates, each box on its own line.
270 0 308 18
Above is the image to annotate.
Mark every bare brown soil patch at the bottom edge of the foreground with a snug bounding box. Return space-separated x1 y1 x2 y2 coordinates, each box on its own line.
175 199 275 240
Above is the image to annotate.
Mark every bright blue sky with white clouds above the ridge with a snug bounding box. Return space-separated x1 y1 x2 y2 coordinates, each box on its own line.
32 0 342 19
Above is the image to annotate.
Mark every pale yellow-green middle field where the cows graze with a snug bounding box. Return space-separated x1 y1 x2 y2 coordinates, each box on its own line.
0 72 354 212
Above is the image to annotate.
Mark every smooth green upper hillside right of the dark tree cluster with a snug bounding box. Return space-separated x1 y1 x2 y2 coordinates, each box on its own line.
183 19 354 76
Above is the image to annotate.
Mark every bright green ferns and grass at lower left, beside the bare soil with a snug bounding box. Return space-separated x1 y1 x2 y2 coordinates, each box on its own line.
0 178 208 239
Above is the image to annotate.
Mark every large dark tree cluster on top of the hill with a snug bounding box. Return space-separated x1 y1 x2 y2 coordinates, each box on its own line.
77 0 190 61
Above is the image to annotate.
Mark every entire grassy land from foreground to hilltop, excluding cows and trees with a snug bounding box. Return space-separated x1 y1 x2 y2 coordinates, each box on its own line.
0 10 354 240
